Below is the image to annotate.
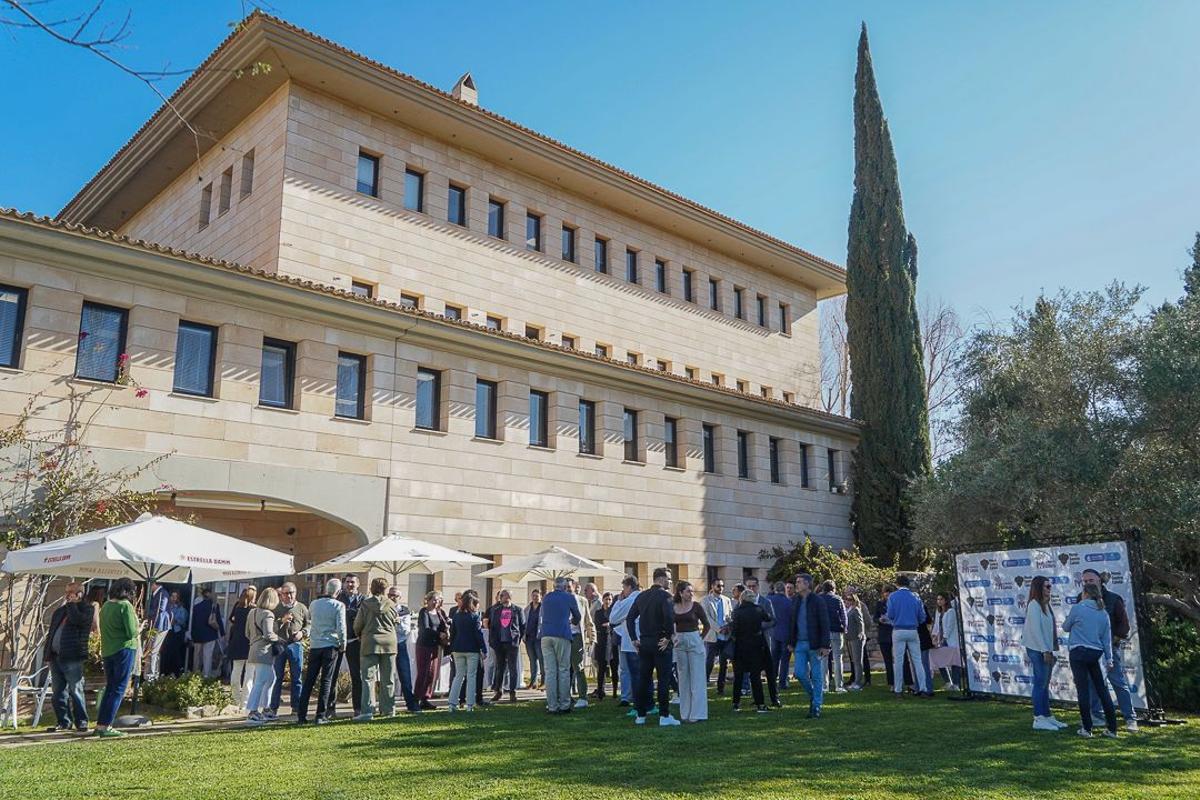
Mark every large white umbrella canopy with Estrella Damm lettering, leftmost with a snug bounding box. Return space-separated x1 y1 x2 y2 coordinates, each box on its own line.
0 513 293 583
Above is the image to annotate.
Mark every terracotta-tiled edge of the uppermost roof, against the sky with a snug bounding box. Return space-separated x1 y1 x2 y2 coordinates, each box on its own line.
59 8 845 281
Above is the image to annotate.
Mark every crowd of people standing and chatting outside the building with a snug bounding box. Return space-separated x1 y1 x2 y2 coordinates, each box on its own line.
37 567 1138 736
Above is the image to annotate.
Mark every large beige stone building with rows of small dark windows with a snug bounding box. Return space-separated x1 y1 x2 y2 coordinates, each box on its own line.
0 13 857 604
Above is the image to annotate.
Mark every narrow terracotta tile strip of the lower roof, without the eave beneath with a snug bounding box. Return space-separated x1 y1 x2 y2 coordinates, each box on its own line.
0 207 856 425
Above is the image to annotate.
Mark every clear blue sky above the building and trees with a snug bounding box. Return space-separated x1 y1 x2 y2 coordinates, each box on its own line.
0 0 1200 319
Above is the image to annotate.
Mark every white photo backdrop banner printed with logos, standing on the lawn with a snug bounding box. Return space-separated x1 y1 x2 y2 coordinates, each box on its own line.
958 542 1147 709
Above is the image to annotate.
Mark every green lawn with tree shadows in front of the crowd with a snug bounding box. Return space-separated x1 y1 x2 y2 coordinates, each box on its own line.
0 688 1200 800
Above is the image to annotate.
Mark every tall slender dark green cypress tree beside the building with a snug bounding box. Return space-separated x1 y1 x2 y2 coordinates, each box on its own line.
846 24 930 565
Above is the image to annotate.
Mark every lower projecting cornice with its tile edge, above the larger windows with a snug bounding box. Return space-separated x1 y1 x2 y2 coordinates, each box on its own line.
0 209 860 437
